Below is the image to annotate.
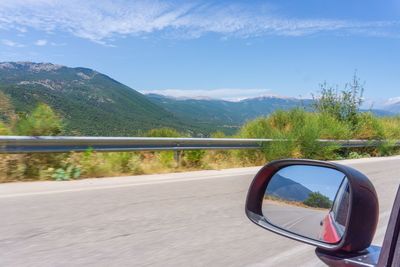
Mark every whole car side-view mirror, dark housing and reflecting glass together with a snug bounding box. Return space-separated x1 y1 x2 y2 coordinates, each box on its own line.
246 160 379 253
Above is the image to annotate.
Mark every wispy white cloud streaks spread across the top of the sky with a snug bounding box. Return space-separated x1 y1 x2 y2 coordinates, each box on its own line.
0 0 400 44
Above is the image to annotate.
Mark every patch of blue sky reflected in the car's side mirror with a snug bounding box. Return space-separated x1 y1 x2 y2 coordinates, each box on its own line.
278 165 345 200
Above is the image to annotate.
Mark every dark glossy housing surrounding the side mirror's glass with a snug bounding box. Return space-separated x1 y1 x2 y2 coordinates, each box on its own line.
246 159 379 252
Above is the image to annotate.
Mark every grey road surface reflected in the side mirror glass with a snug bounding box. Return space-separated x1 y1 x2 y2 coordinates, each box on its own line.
262 199 329 240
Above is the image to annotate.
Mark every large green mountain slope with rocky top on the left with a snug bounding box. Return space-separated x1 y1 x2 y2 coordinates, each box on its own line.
0 62 205 136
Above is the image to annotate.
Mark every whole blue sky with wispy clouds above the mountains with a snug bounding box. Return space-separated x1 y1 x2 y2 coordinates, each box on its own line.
0 0 400 106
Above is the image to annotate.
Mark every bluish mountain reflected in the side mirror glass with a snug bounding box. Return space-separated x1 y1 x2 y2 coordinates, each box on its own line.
266 174 312 202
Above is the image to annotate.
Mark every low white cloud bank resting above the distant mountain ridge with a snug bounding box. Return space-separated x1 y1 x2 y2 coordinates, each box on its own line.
141 88 278 101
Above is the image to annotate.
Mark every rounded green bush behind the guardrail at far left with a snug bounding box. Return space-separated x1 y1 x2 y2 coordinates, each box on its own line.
16 104 64 136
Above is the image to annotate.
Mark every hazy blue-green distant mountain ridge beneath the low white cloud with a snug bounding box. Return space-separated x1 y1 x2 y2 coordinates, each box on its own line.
146 94 313 128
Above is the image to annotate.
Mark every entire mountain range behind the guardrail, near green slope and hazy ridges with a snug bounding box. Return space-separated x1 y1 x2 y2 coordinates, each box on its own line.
0 62 400 136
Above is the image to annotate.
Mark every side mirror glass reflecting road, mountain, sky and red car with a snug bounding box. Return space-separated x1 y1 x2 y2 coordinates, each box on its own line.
262 165 350 244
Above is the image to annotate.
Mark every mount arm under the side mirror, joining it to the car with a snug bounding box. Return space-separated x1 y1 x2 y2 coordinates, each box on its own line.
315 246 381 267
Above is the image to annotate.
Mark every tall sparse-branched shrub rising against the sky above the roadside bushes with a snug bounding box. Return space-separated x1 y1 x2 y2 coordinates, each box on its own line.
313 72 364 127
